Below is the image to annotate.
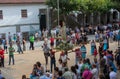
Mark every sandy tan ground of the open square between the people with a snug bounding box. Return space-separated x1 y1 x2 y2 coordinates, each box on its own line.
1 35 120 79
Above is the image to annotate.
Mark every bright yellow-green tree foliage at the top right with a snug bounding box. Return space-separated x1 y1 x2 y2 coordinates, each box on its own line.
78 0 111 13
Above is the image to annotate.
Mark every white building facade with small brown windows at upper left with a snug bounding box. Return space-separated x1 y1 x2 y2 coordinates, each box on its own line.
0 3 49 39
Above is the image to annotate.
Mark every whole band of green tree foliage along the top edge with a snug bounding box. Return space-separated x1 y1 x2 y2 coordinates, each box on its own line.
47 0 120 14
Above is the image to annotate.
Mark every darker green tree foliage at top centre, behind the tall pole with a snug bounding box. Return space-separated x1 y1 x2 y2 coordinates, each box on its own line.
47 0 79 14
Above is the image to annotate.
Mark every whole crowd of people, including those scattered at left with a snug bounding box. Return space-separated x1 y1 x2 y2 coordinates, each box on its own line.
0 24 120 79
